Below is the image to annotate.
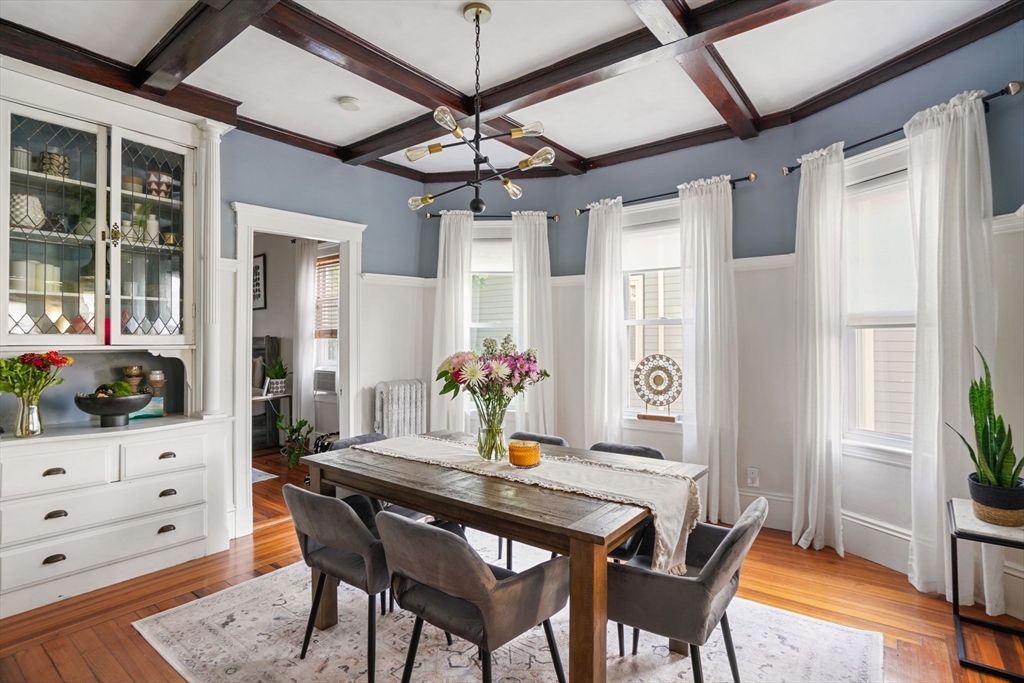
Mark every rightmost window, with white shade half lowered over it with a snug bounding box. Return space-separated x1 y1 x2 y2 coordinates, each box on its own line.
844 143 918 449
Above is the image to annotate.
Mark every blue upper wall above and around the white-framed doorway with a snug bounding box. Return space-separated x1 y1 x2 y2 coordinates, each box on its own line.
220 130 423 275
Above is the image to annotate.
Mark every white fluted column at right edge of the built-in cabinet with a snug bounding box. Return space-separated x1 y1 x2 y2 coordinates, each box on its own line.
199 121 231 419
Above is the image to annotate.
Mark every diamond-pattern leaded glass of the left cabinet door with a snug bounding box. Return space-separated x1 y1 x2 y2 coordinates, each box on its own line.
7 114 102 335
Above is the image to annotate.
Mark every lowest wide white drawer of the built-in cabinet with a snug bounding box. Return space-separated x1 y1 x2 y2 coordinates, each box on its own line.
0 505 206 592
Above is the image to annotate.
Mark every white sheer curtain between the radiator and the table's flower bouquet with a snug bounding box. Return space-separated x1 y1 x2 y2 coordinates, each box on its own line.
427 211 473 431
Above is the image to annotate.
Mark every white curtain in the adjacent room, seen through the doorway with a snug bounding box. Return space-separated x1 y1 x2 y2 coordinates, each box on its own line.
291 240 316 427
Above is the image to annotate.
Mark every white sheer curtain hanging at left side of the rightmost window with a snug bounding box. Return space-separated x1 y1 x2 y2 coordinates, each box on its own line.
793 142 845 556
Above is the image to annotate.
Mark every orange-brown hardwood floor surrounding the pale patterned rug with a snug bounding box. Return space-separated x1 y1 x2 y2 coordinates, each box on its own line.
0 520 1024 683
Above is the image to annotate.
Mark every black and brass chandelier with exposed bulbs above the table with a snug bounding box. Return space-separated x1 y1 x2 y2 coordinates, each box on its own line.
406 2 555 213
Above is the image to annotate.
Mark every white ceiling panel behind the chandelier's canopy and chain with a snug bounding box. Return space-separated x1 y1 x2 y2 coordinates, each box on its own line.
299 0 643 93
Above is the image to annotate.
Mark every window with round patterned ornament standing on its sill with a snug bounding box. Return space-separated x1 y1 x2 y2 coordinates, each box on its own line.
623 200 693 415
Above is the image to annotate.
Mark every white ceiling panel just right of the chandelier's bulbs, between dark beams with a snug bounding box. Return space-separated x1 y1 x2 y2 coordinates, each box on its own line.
512 59 724 157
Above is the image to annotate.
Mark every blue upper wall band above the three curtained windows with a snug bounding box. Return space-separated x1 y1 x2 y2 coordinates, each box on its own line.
420 23 1024 278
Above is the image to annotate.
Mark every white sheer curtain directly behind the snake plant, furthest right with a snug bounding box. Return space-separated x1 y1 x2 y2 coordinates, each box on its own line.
903 91 1005 614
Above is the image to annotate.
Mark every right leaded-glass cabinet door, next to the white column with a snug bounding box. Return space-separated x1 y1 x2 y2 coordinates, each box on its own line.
110 128 195 346
